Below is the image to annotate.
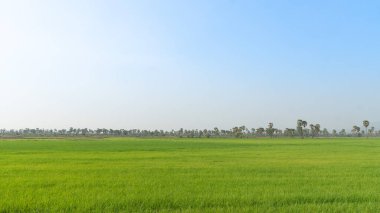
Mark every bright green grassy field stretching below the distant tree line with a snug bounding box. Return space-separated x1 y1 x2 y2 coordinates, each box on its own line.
0 138 380 212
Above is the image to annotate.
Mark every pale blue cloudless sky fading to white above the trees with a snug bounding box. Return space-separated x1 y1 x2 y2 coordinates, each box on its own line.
0 0 380 130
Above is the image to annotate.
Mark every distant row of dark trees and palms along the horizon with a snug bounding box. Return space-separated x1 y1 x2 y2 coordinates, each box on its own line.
0 119 380 138
